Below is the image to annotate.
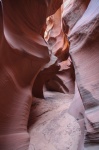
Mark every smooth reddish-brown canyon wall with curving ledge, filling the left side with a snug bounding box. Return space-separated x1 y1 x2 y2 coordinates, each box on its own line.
0 0 62 150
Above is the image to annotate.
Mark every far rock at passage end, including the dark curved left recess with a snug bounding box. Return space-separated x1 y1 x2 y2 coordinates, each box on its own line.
33 8 74 98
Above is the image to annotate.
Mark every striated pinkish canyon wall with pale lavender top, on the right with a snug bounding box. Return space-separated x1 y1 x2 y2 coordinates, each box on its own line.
63 0 99 150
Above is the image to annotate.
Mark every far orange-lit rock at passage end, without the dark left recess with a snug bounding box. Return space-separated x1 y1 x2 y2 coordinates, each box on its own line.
46 8 74 93
